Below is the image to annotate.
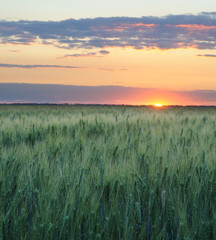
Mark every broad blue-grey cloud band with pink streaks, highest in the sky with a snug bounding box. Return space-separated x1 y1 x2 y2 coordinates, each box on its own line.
0 12 216 50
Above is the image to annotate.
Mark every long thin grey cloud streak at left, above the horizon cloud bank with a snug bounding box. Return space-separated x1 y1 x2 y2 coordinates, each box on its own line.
0 63 83 69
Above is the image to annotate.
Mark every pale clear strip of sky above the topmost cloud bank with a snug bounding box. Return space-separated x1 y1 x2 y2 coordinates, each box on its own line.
0 0 216 20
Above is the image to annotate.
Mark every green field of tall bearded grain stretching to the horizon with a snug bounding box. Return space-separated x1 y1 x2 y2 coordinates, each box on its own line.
0 105 216 240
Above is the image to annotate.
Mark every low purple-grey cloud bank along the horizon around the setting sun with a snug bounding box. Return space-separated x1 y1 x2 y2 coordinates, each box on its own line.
0 83 216 105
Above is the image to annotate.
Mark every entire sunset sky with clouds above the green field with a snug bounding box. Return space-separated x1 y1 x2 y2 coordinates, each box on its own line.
0 0 216 105
